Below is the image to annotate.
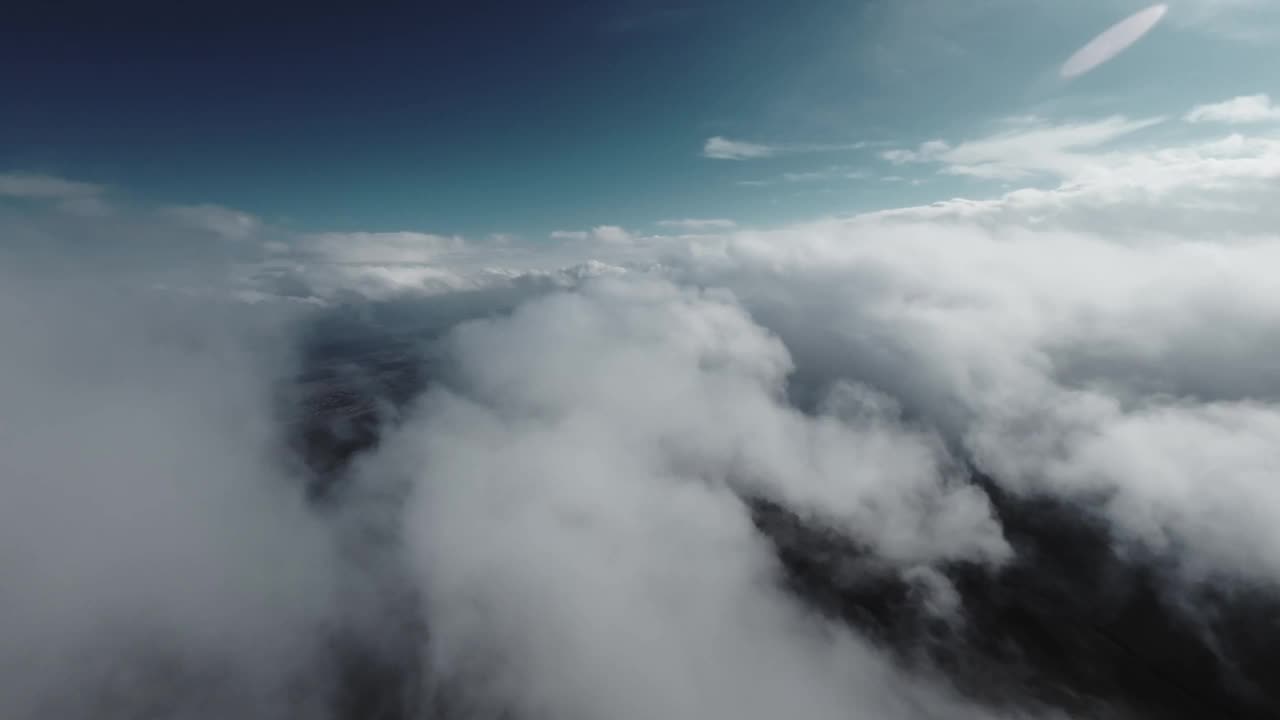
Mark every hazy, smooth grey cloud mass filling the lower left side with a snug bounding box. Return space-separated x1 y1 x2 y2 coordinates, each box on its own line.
0 263 339 719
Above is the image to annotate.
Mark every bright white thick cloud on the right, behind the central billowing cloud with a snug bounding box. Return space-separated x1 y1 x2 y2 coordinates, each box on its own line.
670 213 1280 582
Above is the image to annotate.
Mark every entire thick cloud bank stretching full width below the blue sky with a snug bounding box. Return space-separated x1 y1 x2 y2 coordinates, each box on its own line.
0 107 1280 720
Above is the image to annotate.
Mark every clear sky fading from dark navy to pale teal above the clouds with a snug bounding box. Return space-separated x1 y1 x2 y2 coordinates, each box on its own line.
0 0 1277 241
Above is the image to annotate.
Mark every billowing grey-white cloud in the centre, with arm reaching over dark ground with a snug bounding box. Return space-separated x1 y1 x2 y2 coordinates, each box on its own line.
366 278 1007 717
